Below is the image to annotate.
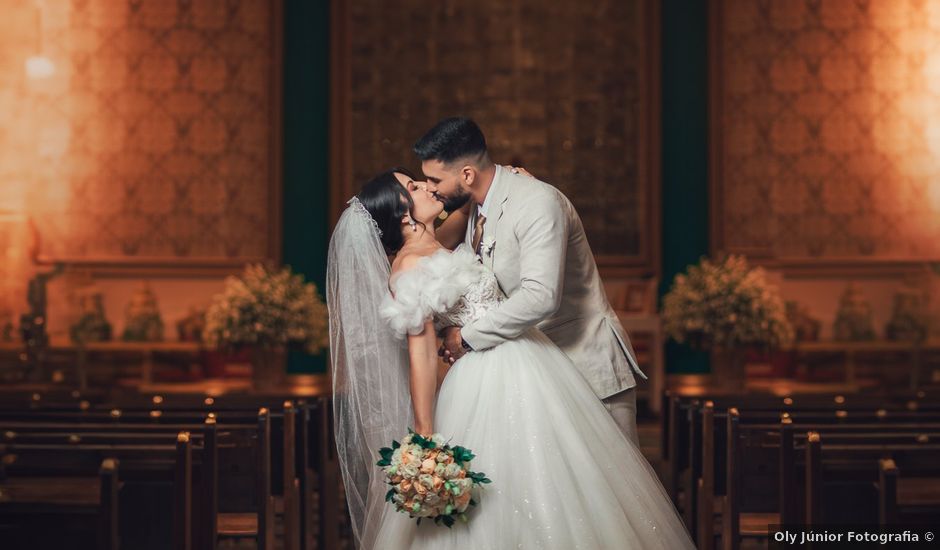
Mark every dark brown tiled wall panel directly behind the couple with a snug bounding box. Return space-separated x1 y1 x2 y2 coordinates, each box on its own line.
342 0 658 268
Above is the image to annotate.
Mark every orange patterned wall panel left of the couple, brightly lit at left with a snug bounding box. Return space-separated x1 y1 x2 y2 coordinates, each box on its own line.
0 0 279 264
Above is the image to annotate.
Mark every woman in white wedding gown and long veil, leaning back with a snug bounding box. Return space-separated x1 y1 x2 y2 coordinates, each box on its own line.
327 169 694 550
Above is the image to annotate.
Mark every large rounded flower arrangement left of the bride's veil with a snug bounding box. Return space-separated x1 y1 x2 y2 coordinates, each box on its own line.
205 264 329 354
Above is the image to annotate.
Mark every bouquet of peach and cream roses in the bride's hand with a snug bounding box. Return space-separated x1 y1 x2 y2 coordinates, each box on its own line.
376 430 490 527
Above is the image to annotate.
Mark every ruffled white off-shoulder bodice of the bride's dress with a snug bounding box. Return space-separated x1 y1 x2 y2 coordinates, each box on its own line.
381 245 504 337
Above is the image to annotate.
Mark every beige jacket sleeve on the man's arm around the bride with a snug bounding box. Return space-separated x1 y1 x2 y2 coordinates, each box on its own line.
461 192 568 350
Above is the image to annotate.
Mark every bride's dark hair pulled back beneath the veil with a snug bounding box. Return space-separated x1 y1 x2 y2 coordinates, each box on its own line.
357 167 424 254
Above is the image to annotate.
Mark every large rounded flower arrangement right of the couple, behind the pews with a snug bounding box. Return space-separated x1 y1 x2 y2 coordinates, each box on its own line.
662 255 793 349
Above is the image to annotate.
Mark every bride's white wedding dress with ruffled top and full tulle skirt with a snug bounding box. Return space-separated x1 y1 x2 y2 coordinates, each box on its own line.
374 246 694 550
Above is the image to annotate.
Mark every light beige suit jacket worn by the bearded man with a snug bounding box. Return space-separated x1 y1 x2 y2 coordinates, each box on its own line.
461 168 646 399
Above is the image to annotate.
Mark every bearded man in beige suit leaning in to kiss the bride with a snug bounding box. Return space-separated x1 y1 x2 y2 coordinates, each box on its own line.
414 118 646 445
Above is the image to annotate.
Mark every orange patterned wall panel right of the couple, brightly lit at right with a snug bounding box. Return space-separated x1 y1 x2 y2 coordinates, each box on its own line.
712 0 940 261
